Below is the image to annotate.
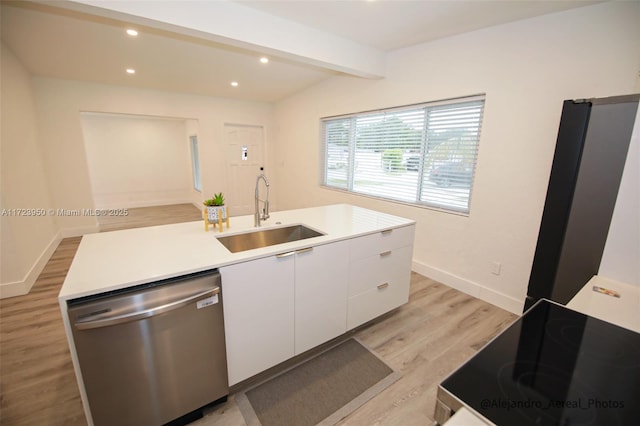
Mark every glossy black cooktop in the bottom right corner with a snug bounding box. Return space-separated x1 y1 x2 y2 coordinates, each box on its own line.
440 299 640 426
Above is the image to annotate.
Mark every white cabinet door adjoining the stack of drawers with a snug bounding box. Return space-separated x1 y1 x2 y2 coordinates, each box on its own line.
295 241 349 354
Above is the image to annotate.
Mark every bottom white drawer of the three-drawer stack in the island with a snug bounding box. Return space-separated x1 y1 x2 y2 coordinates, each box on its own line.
347 274 410 330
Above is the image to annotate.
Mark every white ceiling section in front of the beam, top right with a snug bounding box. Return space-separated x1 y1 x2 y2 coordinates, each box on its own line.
237 0 597 51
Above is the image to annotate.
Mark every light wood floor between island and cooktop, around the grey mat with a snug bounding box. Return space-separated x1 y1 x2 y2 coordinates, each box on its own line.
192 272 517 426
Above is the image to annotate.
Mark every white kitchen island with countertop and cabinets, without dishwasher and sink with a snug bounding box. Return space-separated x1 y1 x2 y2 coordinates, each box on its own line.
59 204 415 422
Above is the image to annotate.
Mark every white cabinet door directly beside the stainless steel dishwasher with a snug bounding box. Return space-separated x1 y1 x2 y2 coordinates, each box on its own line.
220 256 295 385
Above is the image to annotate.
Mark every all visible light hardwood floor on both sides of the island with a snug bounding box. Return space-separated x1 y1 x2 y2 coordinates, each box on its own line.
0 205 516 426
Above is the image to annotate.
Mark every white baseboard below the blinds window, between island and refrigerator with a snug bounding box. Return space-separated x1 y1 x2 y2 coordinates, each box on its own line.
411 260 524 315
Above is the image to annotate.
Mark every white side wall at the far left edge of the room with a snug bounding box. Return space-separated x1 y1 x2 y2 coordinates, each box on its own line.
0 44 59 298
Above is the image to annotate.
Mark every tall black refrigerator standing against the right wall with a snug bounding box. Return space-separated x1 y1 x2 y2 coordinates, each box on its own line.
524 94 640 310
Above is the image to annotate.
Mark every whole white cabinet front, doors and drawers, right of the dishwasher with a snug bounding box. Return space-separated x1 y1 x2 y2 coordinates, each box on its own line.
220 225 414 385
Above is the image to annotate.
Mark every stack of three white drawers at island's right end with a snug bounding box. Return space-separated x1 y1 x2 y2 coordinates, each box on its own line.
347 225 415 330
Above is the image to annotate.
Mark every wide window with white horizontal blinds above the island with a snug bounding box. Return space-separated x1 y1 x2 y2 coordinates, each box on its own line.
321 96 484 213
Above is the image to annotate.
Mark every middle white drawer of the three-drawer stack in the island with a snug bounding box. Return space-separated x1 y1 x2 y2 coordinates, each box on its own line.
349 245 413 297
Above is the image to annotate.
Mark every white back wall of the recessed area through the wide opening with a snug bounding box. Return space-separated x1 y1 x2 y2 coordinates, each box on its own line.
81 113 193 209
